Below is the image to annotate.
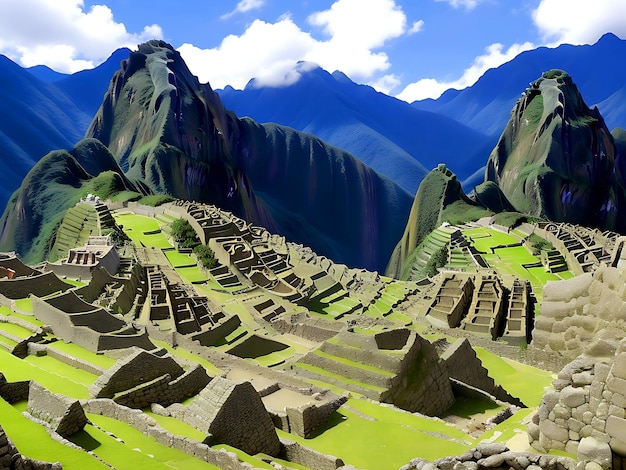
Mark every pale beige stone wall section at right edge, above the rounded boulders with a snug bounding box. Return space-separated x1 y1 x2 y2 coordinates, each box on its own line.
528 266 626 371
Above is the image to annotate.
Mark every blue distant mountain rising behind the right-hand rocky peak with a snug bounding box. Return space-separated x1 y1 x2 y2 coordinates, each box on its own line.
412 33 626 135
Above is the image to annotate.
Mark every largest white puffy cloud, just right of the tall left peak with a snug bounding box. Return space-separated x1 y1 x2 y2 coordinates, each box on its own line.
178 0 407 88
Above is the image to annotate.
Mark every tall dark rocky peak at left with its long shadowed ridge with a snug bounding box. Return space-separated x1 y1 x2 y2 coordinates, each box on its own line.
0 41 412 270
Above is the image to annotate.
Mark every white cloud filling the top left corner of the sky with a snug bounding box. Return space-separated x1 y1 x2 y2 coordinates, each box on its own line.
0 0 163 73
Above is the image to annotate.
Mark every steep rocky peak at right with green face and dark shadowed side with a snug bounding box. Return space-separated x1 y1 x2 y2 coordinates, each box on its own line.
485 70 626 232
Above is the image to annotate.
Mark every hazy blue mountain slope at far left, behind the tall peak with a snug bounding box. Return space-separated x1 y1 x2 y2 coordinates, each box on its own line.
0 49 128 207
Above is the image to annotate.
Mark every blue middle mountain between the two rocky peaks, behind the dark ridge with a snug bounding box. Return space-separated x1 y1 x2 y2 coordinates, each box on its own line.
218 63 495 194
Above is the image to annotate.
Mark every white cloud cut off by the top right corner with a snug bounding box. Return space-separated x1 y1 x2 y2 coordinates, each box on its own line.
533 0 626 46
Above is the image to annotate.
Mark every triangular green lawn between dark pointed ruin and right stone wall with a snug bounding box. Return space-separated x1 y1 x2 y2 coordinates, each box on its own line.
474 347 553 407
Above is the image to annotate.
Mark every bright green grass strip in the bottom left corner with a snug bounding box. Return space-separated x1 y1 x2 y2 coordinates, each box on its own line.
0 399 108 470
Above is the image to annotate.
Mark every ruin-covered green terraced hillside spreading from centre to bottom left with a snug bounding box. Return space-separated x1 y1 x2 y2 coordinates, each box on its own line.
0 196 576 469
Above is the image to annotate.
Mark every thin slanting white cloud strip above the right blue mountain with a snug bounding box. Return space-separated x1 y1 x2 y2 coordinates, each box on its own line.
396 42 535 103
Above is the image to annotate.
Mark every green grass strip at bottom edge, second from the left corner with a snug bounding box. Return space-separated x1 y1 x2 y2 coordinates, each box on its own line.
86 413 218 470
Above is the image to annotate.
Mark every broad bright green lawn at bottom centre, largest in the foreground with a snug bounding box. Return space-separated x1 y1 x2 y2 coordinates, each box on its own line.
277 399 474 470
